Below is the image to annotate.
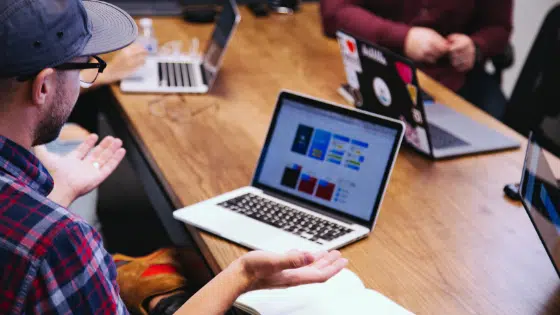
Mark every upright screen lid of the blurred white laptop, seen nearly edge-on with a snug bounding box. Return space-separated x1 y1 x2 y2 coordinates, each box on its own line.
202 0 241 90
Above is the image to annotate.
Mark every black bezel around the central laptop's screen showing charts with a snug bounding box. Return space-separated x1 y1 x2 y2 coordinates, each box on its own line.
251 91 405 227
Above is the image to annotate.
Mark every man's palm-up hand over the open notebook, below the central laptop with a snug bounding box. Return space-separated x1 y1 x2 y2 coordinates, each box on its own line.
240 251 348 291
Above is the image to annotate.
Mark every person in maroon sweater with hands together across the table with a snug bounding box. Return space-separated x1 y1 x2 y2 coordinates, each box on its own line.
321 0 513 118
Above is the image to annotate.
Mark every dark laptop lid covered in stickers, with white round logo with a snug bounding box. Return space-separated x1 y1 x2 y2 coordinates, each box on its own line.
337 30 434 157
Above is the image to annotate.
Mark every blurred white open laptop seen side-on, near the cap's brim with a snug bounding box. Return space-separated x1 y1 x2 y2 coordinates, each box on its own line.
120 0 241 93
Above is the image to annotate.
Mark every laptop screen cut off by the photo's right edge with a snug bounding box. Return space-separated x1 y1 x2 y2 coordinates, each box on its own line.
519 135 560 276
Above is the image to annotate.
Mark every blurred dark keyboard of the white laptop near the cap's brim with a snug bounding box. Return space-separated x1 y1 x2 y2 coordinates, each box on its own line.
158 62 196 87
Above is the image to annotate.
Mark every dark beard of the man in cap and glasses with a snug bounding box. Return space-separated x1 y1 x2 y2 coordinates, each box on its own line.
33 89 73 146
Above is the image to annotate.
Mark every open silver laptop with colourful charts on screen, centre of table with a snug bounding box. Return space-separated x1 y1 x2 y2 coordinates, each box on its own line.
173 91 404 252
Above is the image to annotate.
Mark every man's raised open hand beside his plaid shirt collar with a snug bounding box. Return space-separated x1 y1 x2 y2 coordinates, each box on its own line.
35 135 125 207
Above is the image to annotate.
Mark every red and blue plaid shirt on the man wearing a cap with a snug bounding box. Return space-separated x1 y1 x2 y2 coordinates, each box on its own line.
0 136 128 314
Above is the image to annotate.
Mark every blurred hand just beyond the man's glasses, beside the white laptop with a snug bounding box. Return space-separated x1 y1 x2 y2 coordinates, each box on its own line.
96 43 148 85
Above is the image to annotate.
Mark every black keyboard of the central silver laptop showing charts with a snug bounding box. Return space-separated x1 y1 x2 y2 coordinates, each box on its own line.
219 194 352 244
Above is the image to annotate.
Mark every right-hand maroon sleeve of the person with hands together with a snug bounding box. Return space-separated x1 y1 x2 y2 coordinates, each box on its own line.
471 0 513 58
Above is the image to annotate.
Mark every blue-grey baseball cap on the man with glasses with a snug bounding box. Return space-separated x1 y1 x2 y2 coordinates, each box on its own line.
0 0 138 77
